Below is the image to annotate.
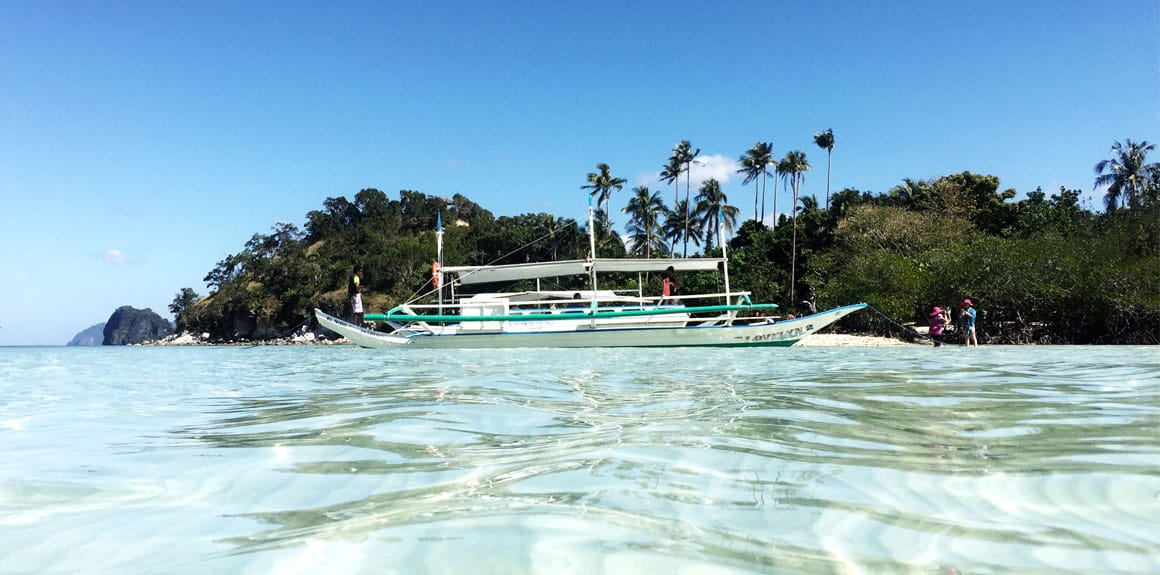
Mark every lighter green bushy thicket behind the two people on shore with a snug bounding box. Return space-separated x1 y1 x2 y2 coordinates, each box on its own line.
802 173 1160 343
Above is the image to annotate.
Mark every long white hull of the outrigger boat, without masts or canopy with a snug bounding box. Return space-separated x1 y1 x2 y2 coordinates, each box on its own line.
314 304 867 349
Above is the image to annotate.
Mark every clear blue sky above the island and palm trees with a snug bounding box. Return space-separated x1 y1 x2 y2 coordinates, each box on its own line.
0 0 1160 345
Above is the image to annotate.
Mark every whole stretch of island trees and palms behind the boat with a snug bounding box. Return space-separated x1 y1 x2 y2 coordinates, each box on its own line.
171 150 1160 343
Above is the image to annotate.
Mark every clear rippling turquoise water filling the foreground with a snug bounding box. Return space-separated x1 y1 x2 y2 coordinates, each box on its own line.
0 347 1160 575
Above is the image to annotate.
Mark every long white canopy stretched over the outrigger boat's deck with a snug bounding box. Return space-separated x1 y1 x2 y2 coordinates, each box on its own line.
442 257 725 285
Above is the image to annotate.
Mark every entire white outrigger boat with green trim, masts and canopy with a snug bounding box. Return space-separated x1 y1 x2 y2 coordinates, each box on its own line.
314 209 867 349
